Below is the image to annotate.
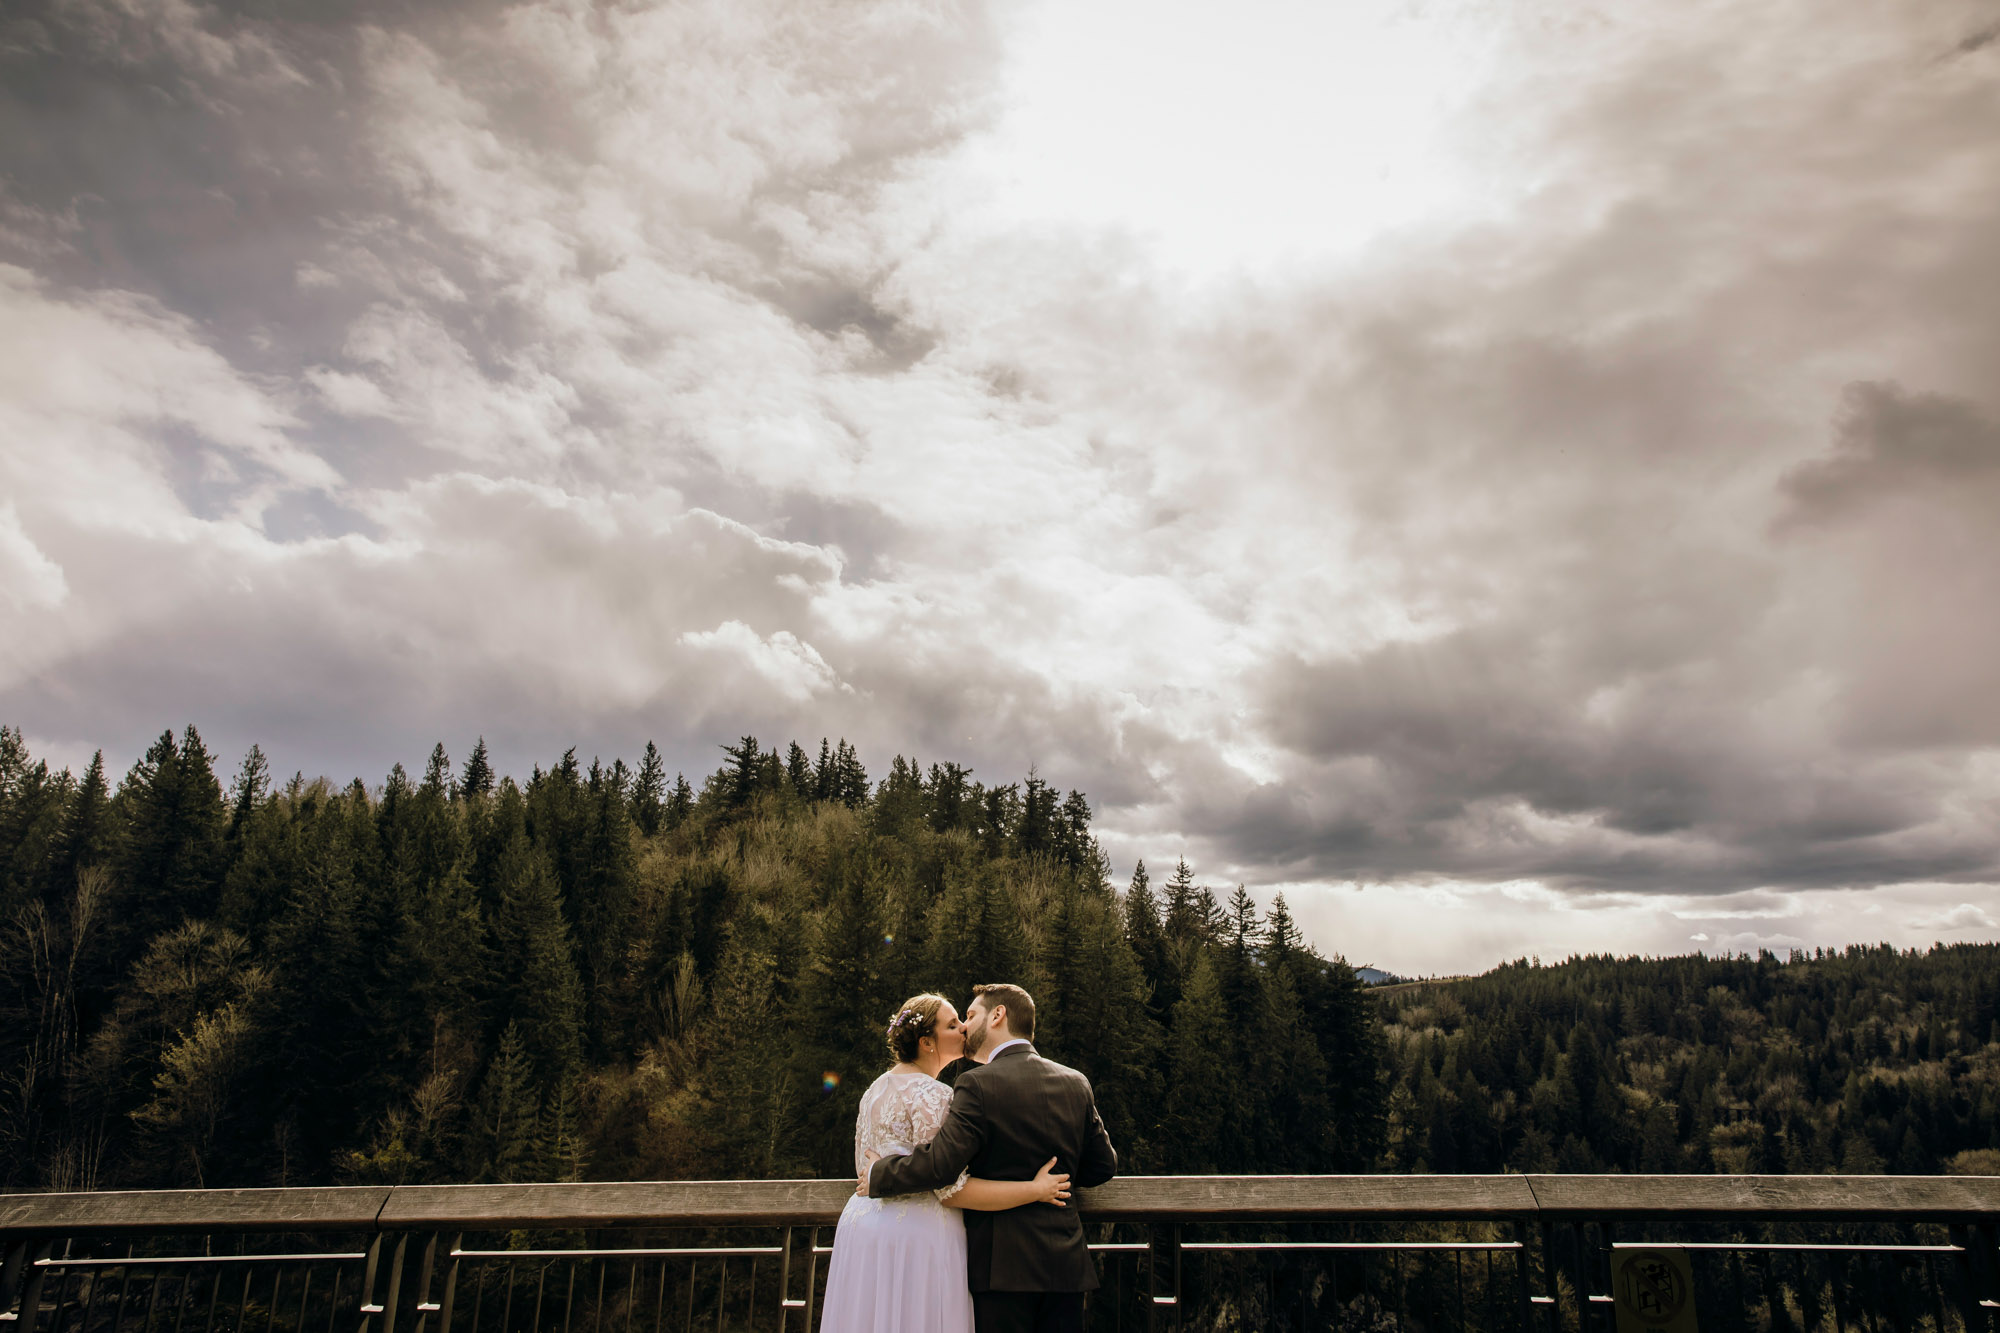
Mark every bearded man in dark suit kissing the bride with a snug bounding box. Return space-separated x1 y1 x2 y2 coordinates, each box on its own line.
868 985 1118 1333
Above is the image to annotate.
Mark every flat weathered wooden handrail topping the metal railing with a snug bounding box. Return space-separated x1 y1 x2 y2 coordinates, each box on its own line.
0 1175 2000 1235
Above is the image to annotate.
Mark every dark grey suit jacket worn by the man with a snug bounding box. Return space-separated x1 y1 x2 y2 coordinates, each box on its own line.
868 1045 1118 1291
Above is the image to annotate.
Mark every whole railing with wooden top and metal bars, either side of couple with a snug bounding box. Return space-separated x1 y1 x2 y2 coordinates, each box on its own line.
0 1175 2000 1333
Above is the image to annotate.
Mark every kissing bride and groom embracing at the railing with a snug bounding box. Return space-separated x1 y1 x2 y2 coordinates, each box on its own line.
820 985 1118 1333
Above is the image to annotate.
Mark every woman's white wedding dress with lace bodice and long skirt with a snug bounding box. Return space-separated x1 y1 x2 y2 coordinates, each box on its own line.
820 1069 972 1333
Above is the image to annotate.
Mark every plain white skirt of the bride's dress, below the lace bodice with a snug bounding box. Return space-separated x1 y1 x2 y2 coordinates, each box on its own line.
820 1193 972 1333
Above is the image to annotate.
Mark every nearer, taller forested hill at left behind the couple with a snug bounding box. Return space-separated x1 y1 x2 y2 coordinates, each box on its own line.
0 729 1384 1189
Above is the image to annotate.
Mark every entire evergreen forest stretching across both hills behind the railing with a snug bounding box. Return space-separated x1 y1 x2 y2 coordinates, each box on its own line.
0 727 2000 1191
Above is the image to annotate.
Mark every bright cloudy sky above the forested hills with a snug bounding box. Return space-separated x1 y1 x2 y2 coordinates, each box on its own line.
0 0 2000 971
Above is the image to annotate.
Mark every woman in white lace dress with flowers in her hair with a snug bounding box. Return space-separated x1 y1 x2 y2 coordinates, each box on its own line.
820 995 1070 1333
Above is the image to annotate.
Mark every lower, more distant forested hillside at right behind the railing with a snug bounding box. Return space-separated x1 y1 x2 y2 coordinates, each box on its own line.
1376 945 2000 1175
